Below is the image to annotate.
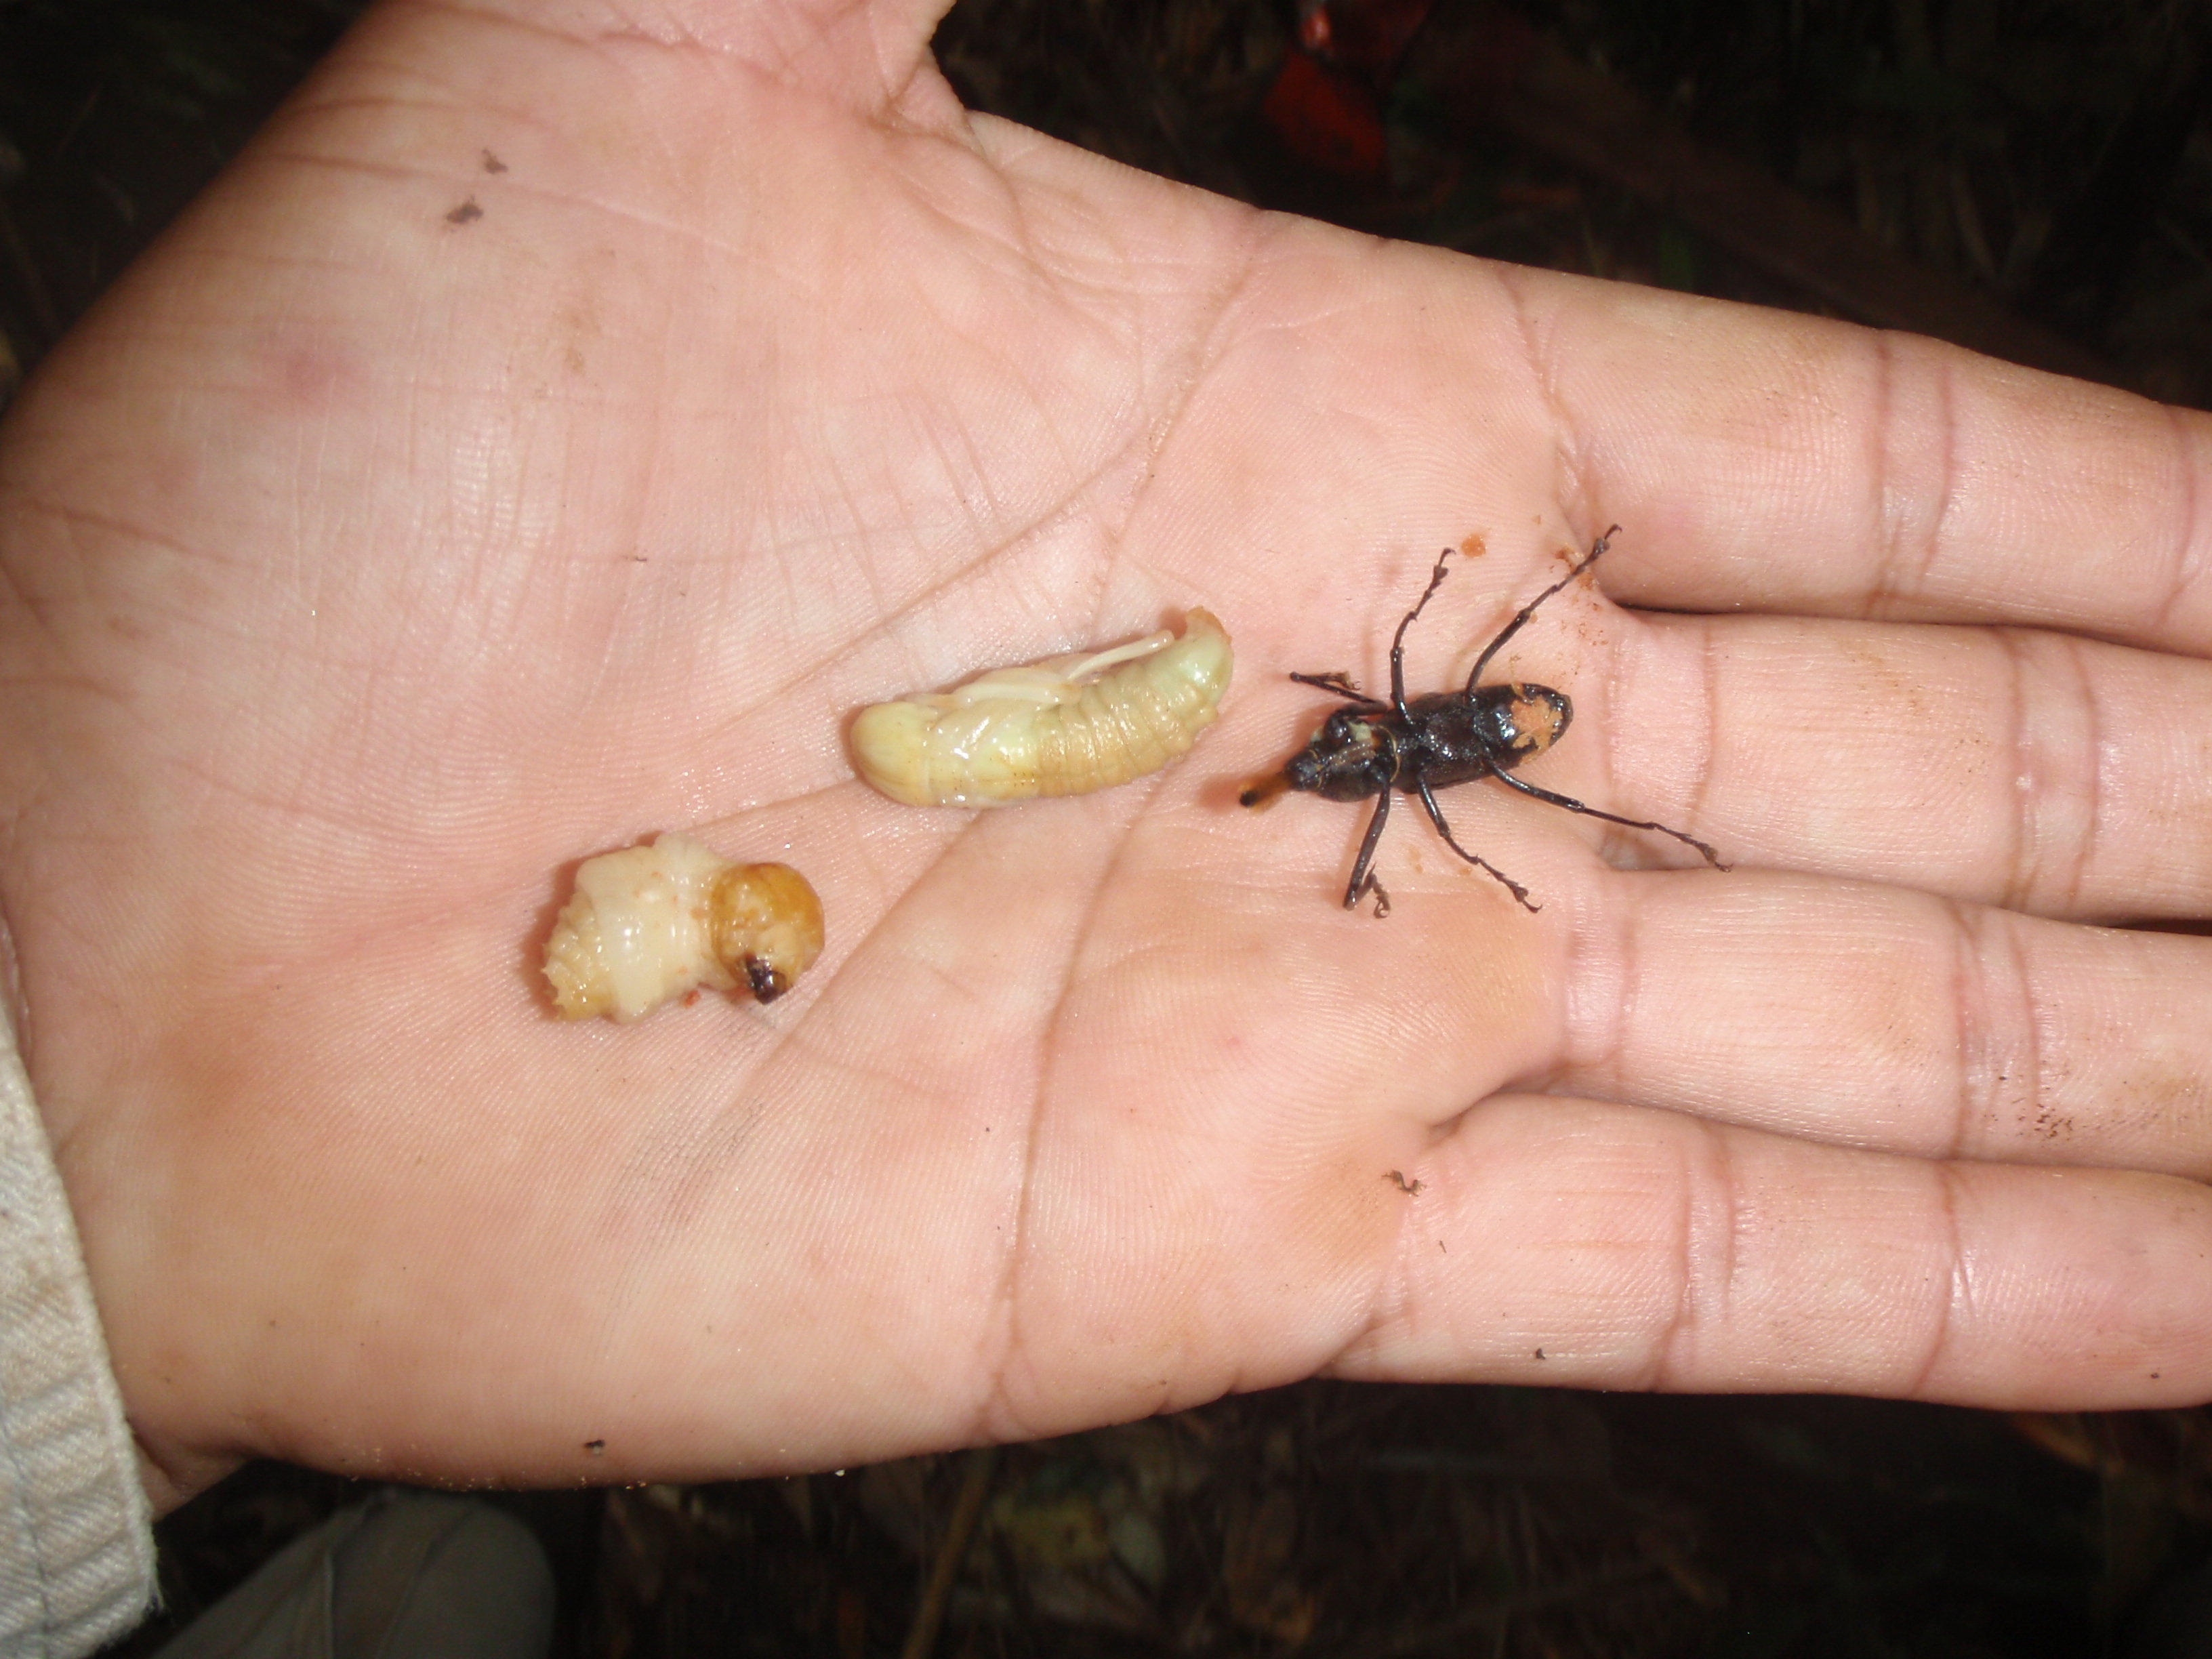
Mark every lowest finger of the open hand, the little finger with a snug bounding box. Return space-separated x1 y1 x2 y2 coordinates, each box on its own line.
1334 1097 2212 1409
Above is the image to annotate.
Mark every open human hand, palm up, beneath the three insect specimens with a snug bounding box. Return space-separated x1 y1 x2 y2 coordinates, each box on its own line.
0 0 2212 1502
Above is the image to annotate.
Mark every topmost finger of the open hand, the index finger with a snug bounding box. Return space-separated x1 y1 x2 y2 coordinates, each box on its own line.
1500 272 2212 651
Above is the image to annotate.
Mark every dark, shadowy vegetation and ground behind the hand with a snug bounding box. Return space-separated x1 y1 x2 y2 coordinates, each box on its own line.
0 0 2212 1659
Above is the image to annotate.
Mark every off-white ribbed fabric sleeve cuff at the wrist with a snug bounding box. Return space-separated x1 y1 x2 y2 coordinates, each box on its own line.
0 1011 155 1659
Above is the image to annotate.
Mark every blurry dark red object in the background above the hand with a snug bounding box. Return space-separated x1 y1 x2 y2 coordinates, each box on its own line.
1261 0 1431 177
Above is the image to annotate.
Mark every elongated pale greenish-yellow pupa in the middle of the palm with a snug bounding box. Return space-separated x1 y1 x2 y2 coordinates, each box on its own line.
852 609 1232 807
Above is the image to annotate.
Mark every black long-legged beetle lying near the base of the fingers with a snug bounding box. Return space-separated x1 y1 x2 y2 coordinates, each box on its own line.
1239 525 1727 916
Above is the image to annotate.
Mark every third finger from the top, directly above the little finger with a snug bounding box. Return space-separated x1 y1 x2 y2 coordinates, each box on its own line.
1557 876 2212 1179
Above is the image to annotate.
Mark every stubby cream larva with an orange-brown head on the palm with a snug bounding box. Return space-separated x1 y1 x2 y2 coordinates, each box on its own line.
546 836 823 1020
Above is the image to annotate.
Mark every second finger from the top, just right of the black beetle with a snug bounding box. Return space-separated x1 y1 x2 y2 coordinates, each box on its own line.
1584 617 2212 918
